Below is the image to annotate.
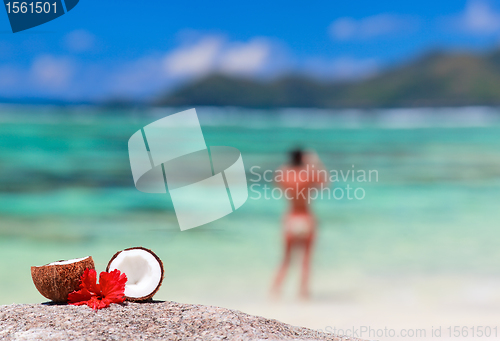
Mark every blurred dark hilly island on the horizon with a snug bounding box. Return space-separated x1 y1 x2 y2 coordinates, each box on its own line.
153 50 500 108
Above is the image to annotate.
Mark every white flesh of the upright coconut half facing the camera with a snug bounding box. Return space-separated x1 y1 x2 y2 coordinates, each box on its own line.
109 249 161 298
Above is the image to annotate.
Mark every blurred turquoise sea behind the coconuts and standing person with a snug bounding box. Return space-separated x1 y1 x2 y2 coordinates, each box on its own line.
0 106 500 334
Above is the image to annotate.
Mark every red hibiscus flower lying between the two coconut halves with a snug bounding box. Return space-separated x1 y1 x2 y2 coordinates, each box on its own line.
68 269 127 311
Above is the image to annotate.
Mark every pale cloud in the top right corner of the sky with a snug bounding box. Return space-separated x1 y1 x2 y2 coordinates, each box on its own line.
451 0 500 34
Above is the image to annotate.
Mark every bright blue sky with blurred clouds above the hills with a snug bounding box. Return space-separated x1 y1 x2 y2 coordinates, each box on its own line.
0 0 500 100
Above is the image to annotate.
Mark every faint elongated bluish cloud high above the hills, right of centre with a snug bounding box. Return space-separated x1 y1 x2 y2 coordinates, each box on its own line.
329 14 417 40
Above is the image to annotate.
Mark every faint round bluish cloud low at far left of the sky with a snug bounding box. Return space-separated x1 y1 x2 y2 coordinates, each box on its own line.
31 55 74 90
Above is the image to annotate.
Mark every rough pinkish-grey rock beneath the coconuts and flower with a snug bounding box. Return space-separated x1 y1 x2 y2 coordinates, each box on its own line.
0 302 368 341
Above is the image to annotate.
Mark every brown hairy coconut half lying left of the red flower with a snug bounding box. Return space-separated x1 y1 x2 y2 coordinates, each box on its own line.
31 256 94 303
